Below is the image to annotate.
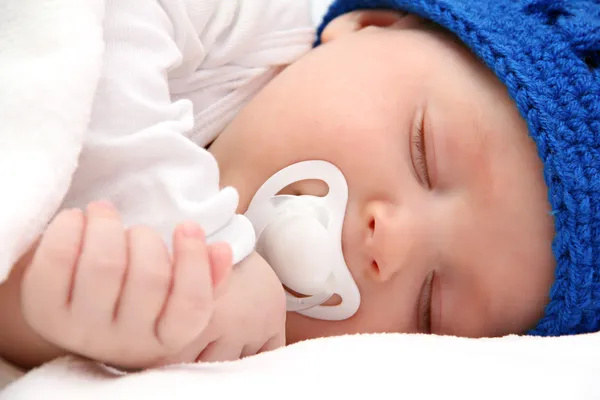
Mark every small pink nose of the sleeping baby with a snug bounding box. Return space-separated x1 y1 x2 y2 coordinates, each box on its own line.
365 201 418 282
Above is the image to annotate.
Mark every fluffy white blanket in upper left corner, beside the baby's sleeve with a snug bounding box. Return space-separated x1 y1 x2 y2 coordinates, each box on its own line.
0 0 104 282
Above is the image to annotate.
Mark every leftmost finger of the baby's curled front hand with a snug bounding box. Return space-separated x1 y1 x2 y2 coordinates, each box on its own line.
21 210 85 343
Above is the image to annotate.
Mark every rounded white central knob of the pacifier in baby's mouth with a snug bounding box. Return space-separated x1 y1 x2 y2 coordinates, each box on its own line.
257 213 334 298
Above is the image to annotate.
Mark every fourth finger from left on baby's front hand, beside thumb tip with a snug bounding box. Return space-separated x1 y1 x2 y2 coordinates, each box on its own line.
156 223 214 350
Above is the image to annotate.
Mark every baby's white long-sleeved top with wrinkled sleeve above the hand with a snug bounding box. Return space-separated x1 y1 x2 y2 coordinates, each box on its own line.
63 0 315 263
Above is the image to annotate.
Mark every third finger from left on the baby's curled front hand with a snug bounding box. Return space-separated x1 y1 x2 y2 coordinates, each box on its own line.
116 226 172 357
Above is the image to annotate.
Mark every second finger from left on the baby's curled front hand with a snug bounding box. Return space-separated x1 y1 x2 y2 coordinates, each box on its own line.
71 202 127 332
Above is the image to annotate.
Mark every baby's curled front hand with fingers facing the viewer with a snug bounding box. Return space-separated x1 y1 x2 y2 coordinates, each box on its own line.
21 203 232 368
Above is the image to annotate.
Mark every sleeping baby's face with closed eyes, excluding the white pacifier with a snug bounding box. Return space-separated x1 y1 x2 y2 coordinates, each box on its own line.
211 12 554 342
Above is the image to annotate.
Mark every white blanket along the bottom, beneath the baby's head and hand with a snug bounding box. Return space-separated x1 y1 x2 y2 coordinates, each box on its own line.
0 334 600 400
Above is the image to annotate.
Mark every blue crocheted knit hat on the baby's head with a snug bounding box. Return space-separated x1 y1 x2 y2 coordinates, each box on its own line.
317 0 600 336
